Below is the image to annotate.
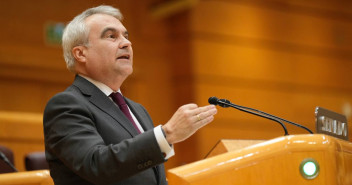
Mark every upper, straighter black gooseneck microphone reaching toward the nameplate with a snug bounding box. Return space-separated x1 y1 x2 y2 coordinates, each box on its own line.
208 97 313 134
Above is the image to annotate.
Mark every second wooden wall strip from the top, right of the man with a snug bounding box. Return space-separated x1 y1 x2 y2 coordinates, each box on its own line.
193 38 352 88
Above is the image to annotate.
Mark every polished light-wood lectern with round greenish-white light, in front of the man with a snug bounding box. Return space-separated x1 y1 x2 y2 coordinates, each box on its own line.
167 134 352 185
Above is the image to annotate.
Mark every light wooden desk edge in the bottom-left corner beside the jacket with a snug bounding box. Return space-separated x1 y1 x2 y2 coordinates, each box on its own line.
0 170 54 185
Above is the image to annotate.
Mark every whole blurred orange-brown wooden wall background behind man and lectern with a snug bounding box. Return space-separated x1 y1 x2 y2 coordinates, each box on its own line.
0 0 352 170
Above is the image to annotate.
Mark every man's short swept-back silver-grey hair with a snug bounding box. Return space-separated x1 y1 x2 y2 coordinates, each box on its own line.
62 5 123 73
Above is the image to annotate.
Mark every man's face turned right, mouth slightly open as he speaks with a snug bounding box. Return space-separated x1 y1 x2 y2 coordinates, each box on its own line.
85 14 133 82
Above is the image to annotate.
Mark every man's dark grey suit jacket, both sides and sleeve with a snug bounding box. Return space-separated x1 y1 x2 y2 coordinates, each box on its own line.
43 76 167 185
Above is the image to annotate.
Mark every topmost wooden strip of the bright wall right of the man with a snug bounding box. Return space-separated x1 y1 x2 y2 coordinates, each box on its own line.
192 0 352 49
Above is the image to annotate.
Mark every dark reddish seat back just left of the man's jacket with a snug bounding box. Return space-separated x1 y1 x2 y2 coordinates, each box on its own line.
25 152 49 171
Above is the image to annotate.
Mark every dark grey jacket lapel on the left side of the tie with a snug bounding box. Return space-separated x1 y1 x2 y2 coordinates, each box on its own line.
73 75 138 136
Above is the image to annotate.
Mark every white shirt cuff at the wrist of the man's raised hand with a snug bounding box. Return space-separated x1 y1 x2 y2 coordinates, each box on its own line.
154 125 175 159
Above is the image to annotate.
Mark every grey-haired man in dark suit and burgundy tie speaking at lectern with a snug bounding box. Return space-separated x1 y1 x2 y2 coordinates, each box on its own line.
44 6 217 185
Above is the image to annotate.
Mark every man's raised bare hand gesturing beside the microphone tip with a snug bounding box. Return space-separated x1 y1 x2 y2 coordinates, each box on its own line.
162 104 217 144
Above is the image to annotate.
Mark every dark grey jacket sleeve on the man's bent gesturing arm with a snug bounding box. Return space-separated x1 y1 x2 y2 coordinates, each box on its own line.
43 93 164 184
